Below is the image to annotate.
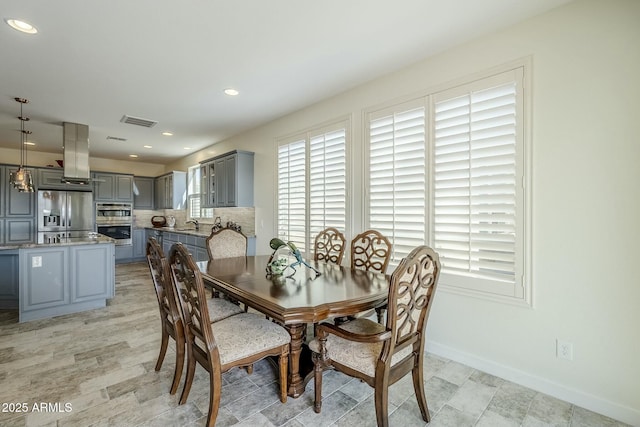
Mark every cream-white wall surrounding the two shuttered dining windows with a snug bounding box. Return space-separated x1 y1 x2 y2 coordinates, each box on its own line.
169 0 640 425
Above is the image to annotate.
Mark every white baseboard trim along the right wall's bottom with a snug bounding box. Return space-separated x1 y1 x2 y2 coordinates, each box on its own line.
426 341 640 426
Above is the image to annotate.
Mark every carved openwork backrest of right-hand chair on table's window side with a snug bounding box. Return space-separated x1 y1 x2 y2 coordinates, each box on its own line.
351 230 391 273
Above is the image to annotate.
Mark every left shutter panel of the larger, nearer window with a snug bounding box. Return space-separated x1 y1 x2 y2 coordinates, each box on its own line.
368 101 427 264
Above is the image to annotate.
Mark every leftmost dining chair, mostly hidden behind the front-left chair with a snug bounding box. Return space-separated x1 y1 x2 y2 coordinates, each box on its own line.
147 237 242 394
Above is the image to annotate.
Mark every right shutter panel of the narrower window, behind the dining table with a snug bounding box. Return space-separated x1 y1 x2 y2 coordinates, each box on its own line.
309 124 347 247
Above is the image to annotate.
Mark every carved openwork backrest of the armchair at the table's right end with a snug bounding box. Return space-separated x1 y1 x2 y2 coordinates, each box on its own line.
382 246 440 359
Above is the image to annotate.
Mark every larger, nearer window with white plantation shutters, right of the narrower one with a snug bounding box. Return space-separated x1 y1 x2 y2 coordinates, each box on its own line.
366 67 530 303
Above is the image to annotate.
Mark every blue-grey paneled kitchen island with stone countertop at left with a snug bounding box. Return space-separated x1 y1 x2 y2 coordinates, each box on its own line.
0 233 115 322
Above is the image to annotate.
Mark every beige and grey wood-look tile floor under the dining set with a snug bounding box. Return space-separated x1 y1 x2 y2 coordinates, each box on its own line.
0 263 624 427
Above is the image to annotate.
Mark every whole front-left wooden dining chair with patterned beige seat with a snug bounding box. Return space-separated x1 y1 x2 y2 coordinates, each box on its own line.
169 243 291 426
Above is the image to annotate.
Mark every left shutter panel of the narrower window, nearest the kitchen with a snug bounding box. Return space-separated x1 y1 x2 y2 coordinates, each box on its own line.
278 139 306 248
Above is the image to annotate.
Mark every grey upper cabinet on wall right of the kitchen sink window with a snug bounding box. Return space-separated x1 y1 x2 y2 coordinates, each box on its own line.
200 150 254 208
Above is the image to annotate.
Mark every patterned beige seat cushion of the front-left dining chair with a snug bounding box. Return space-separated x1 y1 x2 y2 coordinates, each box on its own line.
211 313 291 364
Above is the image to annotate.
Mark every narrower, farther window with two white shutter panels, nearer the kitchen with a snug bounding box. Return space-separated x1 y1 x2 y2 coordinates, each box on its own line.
277 122 347 254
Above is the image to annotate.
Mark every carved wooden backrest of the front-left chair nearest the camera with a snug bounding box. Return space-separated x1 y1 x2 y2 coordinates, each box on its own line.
169 243 220 364
